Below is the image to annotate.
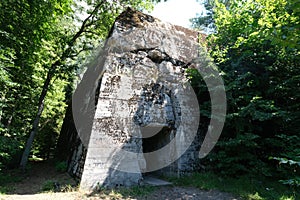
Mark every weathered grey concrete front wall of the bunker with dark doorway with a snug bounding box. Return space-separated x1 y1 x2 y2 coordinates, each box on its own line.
80 9 203 190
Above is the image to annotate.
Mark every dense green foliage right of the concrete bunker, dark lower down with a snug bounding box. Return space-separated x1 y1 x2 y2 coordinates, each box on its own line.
194 0 300 188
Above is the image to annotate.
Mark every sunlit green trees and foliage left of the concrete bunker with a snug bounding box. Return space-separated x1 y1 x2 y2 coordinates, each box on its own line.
0 0 157 170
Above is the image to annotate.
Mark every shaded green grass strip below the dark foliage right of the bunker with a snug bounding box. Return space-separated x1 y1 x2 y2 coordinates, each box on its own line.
168 173 300 200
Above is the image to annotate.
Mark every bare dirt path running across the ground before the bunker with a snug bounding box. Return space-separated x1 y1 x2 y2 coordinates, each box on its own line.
0 163 238 200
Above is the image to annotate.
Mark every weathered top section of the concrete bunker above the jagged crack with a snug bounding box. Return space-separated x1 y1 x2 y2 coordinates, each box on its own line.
105 7 207 60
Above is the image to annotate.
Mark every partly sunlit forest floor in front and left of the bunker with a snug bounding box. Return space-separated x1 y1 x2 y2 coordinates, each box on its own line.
0 162 240 200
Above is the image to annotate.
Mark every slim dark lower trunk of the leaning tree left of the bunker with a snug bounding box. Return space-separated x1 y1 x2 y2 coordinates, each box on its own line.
20 68 55 170
